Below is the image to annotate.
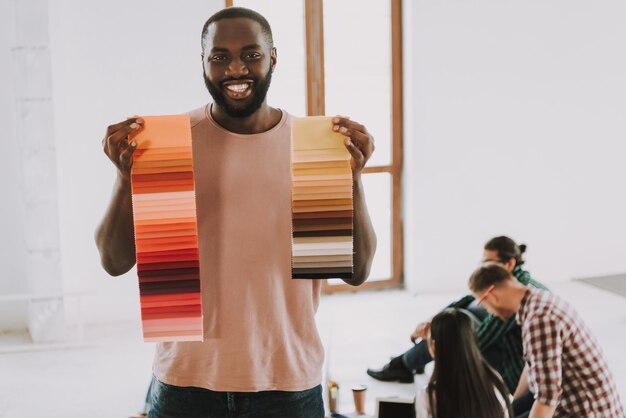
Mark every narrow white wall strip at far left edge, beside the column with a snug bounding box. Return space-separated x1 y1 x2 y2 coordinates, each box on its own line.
0 1 28 329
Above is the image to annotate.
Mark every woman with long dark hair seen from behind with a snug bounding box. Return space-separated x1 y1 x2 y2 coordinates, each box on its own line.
416 308 513 418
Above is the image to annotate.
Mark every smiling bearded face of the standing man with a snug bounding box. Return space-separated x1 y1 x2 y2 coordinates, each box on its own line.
202 18 276 117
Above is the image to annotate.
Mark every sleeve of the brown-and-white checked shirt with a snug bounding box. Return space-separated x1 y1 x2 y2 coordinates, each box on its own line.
523 315 563 406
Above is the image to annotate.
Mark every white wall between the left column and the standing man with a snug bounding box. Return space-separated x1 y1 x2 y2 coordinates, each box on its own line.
49 0 224 322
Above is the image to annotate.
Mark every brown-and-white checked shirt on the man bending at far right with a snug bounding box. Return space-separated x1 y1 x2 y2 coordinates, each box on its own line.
517 288 626 418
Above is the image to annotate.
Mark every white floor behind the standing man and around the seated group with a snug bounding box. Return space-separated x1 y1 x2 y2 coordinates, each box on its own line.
0 282 626 418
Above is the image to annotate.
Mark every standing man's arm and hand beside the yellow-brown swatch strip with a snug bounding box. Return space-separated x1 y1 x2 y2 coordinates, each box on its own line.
333 117 376 286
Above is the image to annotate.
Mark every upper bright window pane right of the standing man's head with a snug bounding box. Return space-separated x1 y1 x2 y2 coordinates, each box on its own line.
324 0 392 167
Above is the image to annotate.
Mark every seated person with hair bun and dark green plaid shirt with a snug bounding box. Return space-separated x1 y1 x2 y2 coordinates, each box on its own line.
367 236 547 392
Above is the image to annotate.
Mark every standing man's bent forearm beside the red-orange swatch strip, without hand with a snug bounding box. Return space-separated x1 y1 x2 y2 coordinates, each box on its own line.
96 178 135 276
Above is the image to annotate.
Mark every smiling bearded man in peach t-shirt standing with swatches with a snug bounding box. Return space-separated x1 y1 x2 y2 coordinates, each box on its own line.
96 8 376 418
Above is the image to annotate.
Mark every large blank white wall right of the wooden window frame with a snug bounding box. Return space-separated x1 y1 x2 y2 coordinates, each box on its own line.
405 0 626 291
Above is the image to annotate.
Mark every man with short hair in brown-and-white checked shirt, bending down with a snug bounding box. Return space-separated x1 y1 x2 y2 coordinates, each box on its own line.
469 262 626 418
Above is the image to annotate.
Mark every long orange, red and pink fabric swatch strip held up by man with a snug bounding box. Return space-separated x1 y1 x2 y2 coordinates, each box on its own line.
131 115 203 341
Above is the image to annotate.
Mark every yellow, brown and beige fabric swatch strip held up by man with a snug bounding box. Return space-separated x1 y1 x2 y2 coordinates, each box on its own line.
291 116 353 279
